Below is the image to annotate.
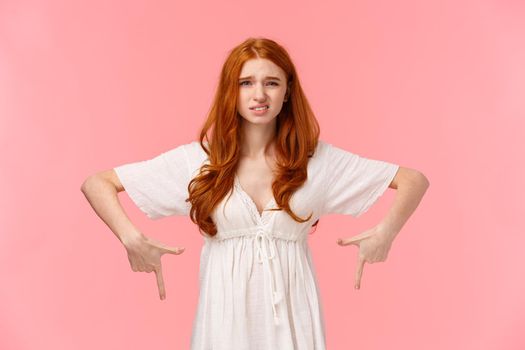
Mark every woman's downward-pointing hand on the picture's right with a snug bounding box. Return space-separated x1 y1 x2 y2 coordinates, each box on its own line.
337 227 393 289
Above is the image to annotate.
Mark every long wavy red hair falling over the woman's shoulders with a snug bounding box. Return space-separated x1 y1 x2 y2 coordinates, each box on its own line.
186 37 320 236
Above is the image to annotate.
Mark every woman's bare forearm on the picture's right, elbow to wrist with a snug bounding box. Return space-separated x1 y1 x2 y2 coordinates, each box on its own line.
378 172 430 240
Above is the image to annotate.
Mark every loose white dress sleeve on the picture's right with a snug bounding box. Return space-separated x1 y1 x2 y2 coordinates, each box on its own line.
323 144 399 217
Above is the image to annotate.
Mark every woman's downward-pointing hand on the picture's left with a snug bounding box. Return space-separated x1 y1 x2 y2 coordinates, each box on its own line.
124 235 184 300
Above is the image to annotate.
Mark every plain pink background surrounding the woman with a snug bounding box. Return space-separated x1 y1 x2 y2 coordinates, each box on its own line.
0 0 525 350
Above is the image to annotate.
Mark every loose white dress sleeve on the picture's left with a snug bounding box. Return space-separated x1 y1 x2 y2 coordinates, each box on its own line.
113 145 190 220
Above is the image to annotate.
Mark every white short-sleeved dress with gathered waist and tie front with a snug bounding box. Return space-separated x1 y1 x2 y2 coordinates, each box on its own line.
114 140 399 350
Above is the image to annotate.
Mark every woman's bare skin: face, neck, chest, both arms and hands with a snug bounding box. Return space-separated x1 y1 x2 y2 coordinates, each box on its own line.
81 58 429 300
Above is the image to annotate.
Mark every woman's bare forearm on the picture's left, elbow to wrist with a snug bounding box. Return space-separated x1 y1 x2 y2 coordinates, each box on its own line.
81 175 142 244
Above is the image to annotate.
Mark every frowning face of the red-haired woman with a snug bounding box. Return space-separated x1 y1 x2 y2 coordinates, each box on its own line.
237 58 287 124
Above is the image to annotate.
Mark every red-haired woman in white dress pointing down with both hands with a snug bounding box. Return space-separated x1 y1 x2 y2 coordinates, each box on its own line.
83 38 428 350
